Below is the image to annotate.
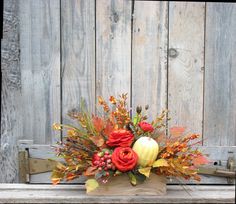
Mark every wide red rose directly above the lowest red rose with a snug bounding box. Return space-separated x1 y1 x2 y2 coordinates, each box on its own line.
106 129 134 147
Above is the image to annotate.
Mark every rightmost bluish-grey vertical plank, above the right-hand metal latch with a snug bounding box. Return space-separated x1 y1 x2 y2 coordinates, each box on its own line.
204 3 236 146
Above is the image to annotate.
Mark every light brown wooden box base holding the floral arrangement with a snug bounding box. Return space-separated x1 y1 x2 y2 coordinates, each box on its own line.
88 174 166 195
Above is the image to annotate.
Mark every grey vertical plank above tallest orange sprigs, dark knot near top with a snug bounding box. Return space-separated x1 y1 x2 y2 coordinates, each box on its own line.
96 0 132 99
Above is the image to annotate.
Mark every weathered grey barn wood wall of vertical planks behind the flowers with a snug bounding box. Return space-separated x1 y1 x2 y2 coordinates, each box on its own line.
0 0 236 182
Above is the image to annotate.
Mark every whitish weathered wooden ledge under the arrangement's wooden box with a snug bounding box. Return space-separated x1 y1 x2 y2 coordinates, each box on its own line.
0 184 235 203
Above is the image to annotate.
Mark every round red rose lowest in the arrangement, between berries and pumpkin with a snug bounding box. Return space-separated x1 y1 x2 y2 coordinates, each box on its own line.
112 147 138 172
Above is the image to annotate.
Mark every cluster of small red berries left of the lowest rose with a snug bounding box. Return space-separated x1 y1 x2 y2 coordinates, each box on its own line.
93 151 115 176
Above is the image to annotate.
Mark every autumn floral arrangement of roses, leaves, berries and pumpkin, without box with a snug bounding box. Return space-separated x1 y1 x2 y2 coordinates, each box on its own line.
51 94 208 192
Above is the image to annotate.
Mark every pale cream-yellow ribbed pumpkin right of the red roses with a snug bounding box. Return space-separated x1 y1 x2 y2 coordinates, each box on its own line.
133 137 159 167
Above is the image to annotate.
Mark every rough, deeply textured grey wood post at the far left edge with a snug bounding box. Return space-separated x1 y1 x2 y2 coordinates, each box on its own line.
0 0 22 183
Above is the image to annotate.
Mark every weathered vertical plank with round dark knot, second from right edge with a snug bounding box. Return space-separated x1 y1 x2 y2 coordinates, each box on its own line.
168 2 205 134
